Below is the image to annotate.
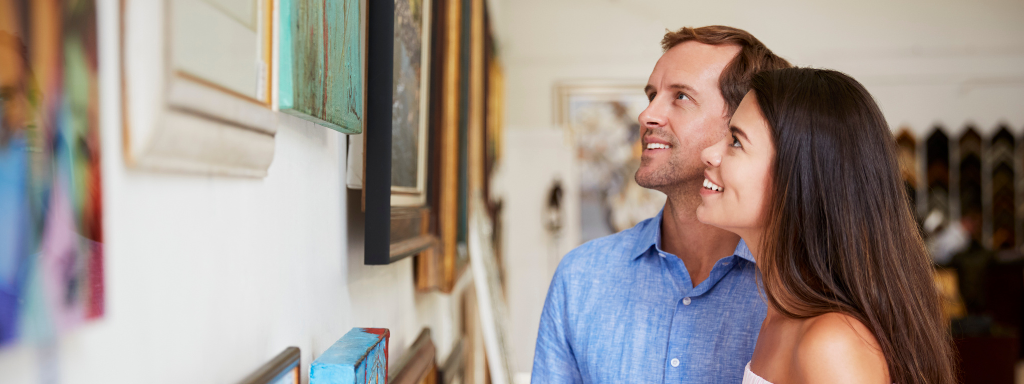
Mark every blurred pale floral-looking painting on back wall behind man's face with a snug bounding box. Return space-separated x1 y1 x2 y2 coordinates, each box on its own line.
556 84 666 243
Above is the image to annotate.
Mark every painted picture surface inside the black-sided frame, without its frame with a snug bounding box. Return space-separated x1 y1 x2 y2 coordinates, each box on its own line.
391 0 430 206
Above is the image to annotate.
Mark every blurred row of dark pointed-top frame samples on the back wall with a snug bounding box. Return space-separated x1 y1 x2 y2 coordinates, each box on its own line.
880 125 1024 256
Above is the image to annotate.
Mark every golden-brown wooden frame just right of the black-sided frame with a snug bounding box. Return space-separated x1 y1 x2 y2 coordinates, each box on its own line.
416 0 475 292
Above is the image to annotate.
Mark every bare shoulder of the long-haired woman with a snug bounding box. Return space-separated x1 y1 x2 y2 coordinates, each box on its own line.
793 312 890 384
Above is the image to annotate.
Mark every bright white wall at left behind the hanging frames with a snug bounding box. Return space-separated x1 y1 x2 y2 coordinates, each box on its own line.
0 0 468 383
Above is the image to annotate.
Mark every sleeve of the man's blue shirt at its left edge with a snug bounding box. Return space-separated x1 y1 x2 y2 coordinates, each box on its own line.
530 260 583 384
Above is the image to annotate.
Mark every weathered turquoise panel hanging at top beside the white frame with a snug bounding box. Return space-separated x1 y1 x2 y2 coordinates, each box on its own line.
279 0 365 133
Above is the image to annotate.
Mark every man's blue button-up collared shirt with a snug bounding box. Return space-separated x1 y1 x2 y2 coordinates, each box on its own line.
532 213 767 383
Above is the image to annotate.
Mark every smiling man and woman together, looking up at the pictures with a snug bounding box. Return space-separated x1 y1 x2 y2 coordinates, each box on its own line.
532 26 954 384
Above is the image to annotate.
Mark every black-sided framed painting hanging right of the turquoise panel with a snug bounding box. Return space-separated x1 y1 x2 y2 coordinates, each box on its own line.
364 0 436 264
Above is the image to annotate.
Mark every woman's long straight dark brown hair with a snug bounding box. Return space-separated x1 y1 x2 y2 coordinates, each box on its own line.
751 68 955 384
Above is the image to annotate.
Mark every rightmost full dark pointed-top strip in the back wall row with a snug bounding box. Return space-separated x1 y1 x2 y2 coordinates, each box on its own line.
988 127 1018 250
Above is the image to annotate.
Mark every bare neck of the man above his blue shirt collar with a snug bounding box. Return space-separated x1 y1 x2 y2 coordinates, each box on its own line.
662 191 739 287
